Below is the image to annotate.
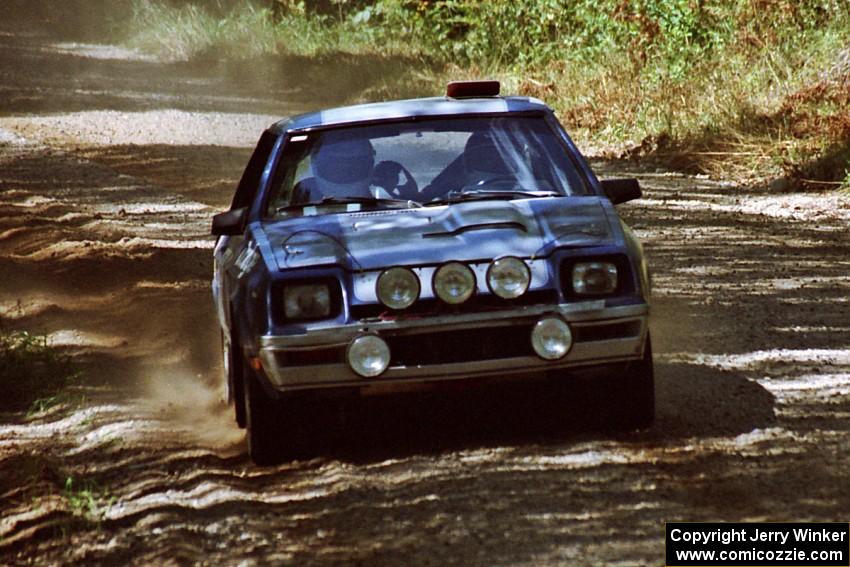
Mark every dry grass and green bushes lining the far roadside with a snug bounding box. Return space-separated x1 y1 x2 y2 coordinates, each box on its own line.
124 0 850 190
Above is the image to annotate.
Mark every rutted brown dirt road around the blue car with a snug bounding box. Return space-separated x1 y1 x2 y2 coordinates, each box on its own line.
0 10 850 565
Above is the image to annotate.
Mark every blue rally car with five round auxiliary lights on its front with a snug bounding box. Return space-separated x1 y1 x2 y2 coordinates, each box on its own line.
212 81 655 464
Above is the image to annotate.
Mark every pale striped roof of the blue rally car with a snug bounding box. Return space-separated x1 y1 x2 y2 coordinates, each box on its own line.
270 96 550 133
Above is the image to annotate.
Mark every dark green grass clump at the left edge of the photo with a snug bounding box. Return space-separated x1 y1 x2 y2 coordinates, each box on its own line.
0 331 79 413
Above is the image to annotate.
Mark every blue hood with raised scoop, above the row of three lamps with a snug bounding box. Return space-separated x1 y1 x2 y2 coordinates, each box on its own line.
263 196 613 270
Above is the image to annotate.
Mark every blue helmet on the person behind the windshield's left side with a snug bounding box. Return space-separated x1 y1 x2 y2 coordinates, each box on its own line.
313 137 375 185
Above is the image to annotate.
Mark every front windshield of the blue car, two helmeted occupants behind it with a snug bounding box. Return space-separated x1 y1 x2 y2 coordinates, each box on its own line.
268 116 588 216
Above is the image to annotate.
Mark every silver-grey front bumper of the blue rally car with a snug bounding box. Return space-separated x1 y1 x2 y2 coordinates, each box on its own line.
259 300 649 392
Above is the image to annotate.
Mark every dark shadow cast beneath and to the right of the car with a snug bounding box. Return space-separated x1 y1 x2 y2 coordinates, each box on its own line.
274 363 776 464
